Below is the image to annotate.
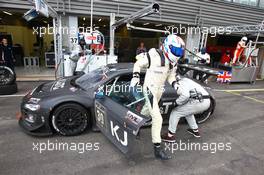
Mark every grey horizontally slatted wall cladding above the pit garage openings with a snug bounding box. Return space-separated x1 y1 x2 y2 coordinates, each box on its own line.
0 0 264 26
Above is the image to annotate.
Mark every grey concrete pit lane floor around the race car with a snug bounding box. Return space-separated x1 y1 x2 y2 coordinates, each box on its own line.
0 81 264 175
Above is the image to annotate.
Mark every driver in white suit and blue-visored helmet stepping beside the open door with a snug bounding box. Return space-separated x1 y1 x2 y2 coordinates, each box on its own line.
130 35 185 160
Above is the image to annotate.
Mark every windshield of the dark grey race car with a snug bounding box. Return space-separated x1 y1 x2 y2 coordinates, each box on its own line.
75 66 109 89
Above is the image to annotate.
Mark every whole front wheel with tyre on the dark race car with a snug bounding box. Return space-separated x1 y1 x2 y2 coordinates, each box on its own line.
52 103 90 136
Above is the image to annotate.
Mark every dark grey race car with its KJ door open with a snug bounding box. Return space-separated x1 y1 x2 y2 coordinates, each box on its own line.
19 63 215 152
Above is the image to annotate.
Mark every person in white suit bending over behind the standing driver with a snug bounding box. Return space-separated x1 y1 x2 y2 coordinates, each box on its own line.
162 78 211 142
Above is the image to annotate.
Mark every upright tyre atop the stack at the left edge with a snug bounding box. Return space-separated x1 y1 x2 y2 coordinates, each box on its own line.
0 66 16 85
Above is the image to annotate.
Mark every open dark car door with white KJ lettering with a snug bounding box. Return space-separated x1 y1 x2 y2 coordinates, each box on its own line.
94 89 149 154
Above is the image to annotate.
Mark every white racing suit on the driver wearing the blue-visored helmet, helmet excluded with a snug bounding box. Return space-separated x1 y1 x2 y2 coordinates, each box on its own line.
133 48 177 143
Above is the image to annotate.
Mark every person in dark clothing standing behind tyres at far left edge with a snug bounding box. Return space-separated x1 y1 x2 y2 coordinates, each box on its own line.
0 38 16 71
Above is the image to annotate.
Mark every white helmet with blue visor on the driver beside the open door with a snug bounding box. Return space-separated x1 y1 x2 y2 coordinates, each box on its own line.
161 34 185 64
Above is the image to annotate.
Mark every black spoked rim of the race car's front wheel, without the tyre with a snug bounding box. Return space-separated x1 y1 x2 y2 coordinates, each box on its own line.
55 108 87 134
